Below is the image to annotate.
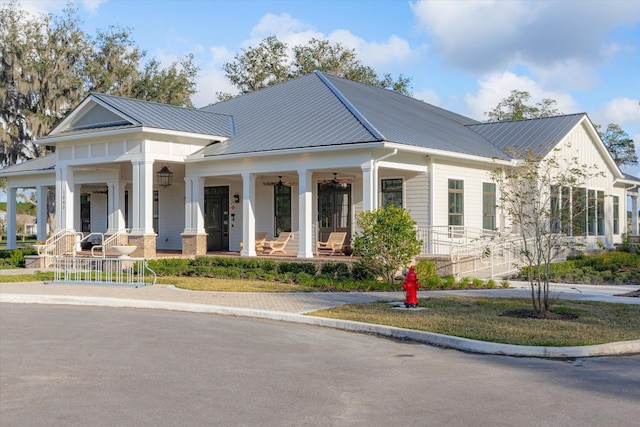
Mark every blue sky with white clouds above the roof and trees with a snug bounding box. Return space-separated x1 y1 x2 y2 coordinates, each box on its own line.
5 0 640 204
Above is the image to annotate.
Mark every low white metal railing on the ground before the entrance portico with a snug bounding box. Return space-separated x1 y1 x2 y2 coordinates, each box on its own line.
53 257 156 288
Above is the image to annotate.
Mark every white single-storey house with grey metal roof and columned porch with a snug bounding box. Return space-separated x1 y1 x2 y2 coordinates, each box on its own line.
0 72 640 266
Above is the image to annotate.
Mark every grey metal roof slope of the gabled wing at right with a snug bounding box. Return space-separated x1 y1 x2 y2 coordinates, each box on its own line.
466 113 586 157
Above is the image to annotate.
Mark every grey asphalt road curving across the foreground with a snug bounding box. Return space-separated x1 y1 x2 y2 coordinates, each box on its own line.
0 304 640 427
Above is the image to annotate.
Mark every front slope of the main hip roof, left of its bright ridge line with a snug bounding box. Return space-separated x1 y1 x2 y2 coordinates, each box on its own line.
197 74 380 156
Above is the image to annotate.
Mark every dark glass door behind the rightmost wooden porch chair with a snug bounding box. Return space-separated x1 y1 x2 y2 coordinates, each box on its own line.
318 182 351 246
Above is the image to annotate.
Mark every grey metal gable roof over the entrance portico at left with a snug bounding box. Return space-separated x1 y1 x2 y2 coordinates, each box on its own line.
51 93 233 137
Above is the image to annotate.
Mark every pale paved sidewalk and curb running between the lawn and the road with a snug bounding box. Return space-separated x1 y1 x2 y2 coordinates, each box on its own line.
0 270 640 358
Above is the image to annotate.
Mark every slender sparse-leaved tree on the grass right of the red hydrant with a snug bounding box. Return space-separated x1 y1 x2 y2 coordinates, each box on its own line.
491 145 602 313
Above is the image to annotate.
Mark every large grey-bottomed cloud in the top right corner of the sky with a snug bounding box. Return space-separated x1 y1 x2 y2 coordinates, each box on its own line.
410 0 640 87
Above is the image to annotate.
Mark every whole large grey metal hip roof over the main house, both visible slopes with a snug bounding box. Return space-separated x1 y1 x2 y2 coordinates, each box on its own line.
194 71 506 158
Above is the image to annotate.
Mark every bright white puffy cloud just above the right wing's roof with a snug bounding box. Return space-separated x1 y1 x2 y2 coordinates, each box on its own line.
465 72 579 121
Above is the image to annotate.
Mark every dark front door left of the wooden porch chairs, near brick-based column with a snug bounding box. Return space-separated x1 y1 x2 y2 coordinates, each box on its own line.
204 187 229 251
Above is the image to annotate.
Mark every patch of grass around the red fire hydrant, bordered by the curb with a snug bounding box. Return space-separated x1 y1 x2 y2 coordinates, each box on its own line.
311 297 640 346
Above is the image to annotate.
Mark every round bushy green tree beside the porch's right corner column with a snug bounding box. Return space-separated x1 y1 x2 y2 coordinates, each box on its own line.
353 206 422 283
